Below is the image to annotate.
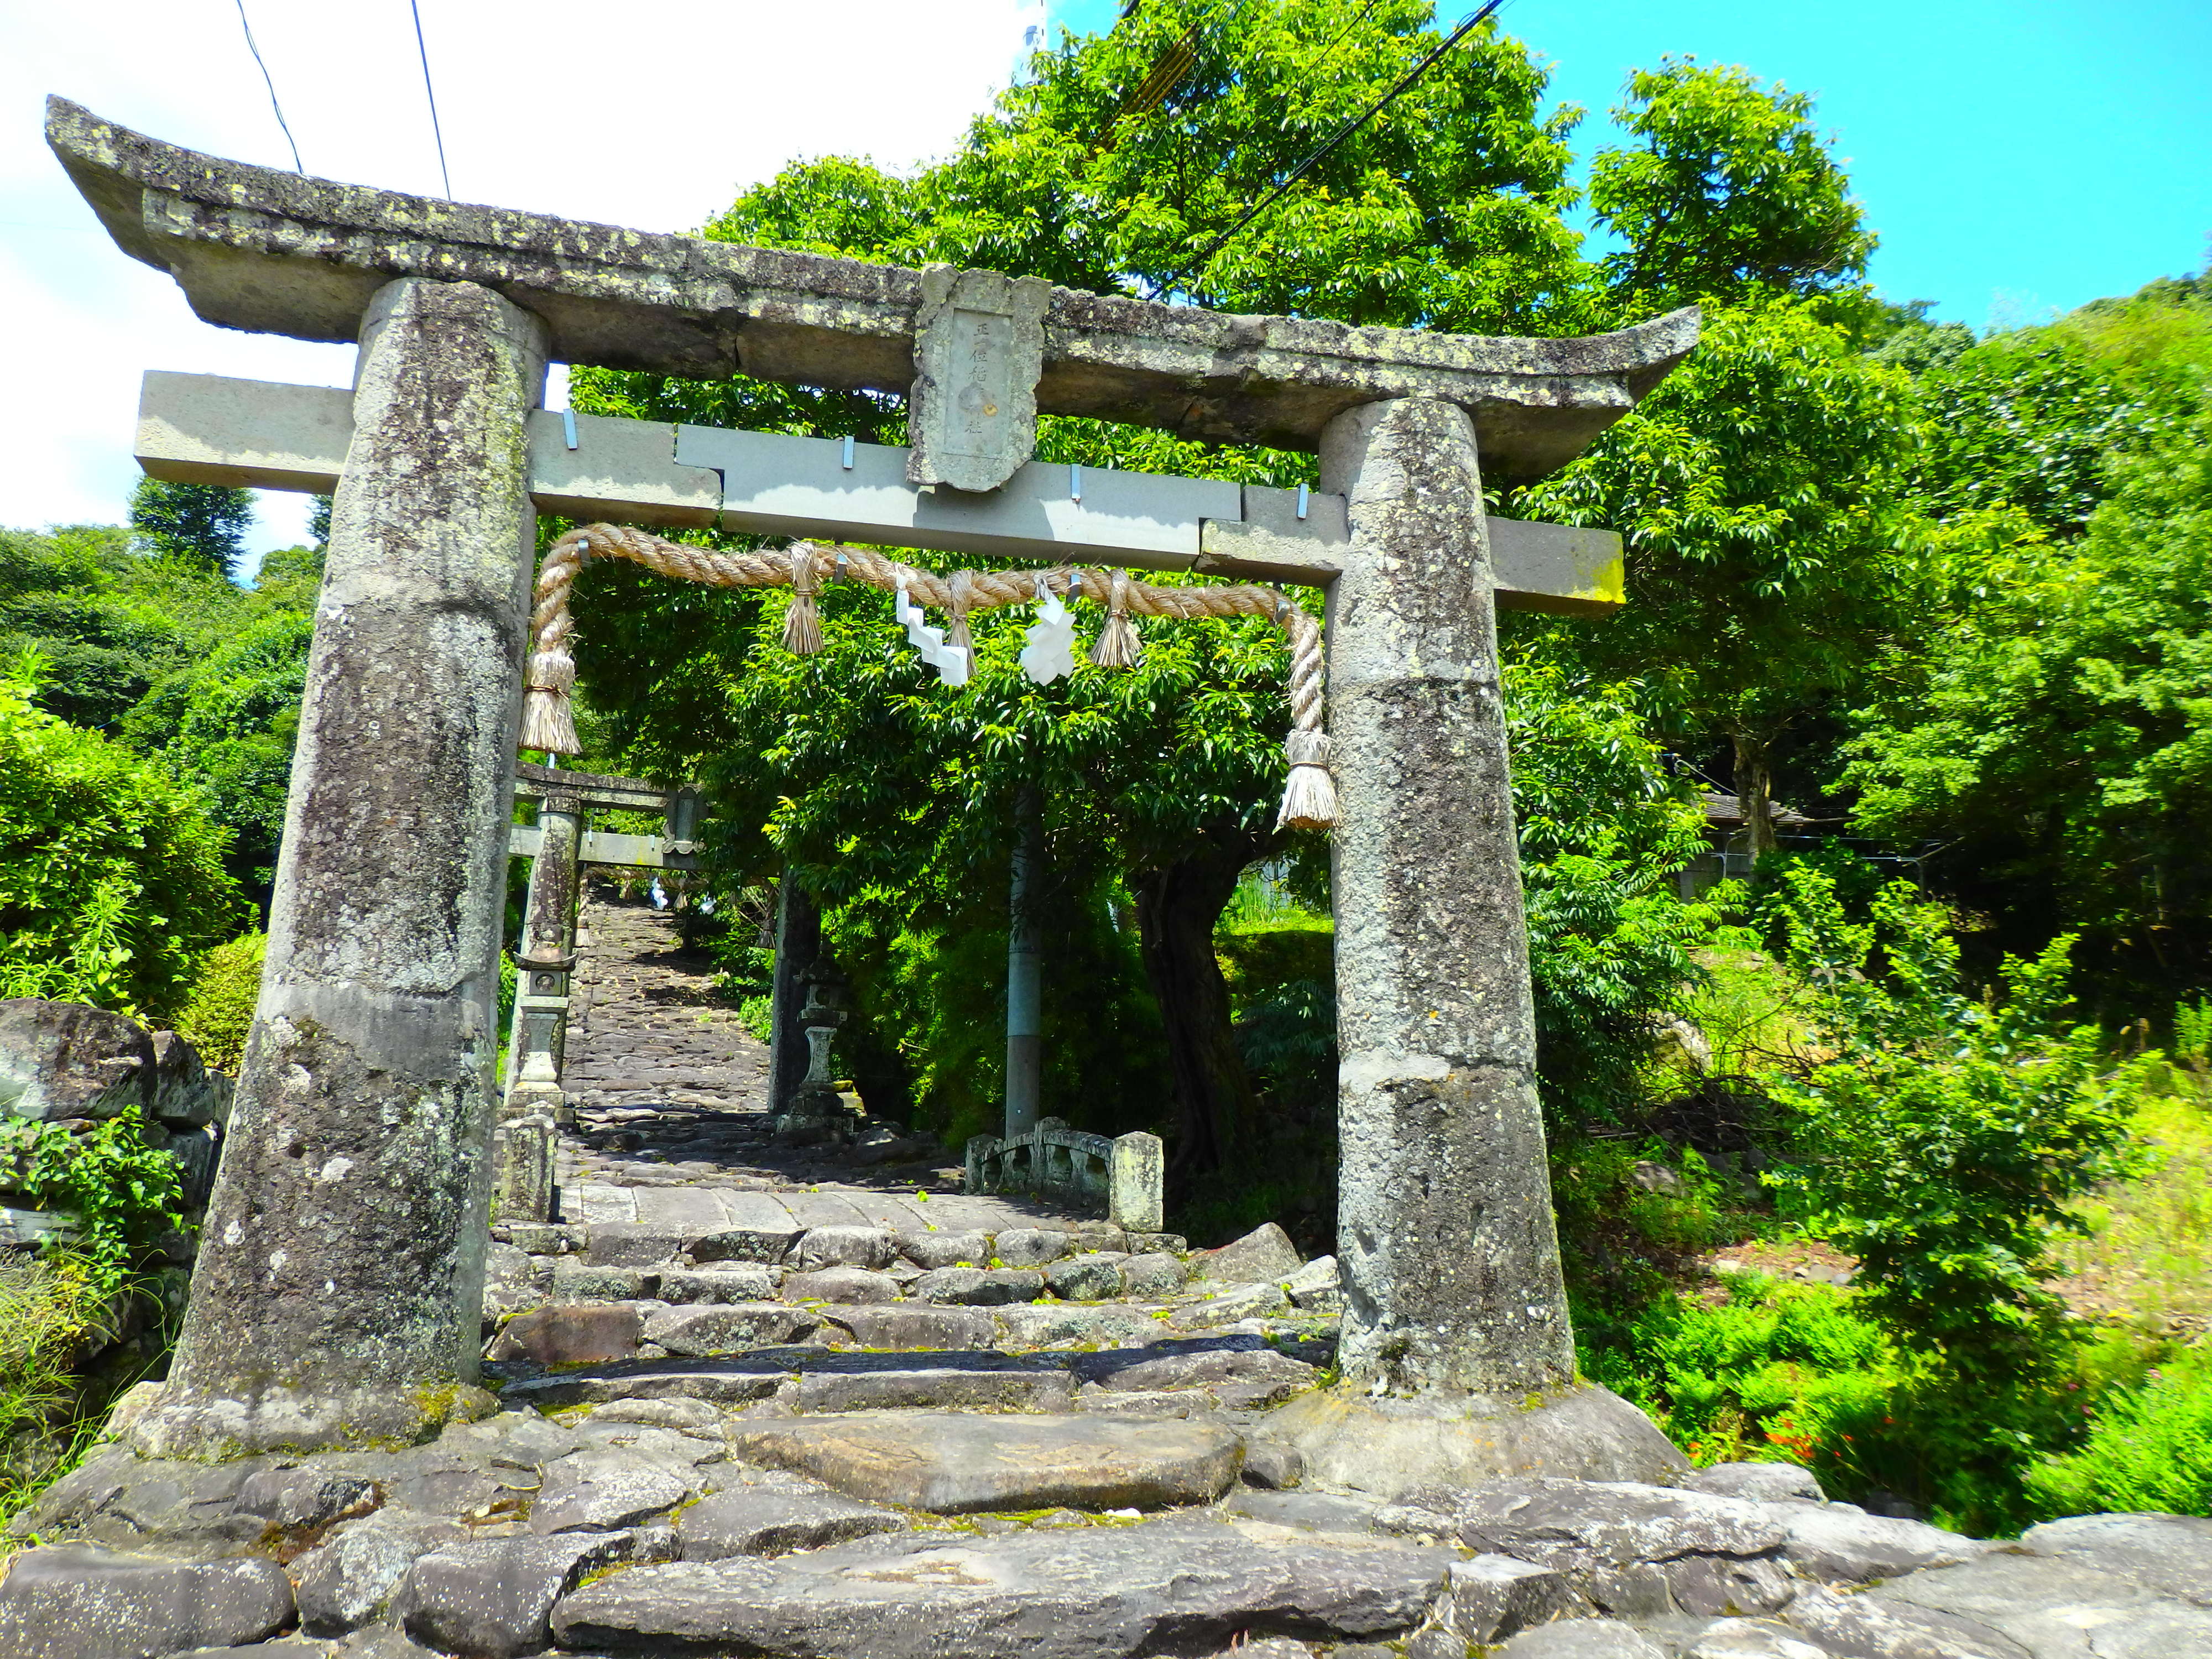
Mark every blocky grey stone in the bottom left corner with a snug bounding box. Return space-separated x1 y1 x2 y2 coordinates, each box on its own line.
0 1544 292 1659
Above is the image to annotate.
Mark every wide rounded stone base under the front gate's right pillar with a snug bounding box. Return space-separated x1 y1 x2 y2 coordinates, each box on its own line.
1267 1385 1690 1498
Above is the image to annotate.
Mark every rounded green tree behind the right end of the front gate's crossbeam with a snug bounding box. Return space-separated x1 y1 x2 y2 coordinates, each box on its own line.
1509 299 1927 856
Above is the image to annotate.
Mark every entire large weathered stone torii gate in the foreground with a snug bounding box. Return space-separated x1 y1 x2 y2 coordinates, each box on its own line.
46 100 1697 1473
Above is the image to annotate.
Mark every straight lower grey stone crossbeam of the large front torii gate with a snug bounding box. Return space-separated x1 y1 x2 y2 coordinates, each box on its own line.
137 372 1621 619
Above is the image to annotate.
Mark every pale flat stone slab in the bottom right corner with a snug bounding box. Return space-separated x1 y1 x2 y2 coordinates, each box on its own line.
1867 1553 2212 1659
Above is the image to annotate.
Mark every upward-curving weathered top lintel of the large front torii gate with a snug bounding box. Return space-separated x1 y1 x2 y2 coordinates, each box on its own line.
46 97 1699 480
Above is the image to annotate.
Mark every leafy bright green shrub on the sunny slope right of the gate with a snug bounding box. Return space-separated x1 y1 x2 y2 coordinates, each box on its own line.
1770 865 2132 1376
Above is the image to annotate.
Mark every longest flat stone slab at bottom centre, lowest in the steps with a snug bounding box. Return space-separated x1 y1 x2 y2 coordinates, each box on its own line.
553 1520 1451 1659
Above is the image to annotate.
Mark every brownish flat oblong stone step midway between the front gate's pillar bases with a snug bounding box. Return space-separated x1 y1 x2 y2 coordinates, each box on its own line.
730 1411 1243 1515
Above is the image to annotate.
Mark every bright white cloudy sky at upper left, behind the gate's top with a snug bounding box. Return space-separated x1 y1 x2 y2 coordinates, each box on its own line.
0 0 1037 560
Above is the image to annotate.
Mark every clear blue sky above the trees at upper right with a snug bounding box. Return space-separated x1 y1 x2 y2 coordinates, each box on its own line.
1048 0 2212 327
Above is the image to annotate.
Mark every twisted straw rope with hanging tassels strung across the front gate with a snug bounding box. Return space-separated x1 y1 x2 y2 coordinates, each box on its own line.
522 524 1336 830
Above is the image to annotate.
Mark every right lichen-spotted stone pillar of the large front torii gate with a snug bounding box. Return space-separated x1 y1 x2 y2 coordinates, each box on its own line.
1321 398 1575 1396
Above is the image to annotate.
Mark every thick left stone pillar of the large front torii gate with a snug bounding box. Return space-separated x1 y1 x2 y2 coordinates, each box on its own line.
135 279 546 1458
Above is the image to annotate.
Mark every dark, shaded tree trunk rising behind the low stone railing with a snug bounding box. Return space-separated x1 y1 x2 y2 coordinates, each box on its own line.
1130 832 1274 1172
